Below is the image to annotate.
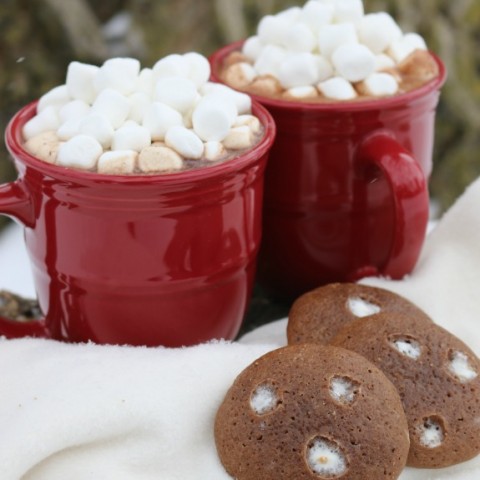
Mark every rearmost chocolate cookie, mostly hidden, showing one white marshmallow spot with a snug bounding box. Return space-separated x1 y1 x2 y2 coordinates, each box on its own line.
287 283 430 345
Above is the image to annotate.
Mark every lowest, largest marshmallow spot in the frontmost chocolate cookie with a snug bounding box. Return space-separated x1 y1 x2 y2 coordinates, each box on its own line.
306 437 348 478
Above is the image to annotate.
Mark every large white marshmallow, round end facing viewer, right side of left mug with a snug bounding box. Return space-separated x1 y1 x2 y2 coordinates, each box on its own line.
192 94 237 142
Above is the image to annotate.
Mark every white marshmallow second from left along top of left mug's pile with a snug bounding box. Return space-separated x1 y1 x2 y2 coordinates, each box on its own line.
93 58 140 95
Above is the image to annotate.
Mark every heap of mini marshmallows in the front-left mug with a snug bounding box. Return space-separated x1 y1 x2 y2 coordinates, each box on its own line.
23 52 262 174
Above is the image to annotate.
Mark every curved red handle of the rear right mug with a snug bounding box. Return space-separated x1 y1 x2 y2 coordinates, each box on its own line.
351 131 429 280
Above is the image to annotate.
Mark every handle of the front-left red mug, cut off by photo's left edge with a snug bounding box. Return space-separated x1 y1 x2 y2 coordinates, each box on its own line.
0 180 49 338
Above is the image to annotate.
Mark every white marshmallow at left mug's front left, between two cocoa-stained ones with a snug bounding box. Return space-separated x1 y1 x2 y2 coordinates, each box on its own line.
57 135 103 170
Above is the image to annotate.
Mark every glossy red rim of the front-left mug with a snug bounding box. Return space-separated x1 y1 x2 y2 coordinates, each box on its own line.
5 99 276 185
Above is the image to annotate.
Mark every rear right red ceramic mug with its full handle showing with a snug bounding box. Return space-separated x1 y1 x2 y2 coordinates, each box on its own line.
210 42 446 298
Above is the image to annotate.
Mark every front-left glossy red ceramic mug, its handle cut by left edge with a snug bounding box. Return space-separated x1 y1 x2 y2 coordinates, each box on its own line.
0 103 275 346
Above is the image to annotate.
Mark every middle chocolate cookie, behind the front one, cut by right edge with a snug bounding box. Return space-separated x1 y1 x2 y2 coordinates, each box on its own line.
332 314 480 468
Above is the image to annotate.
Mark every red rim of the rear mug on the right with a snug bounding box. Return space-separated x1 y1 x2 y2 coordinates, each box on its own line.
209 39 447 112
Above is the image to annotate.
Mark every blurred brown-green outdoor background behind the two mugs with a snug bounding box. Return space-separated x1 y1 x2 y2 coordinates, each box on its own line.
0 0 480 234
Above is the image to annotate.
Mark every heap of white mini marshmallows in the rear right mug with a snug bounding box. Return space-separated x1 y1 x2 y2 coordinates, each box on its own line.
232 0 427 100
